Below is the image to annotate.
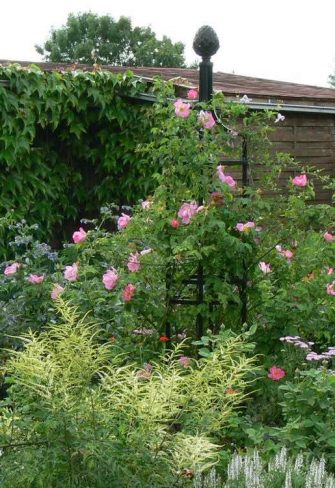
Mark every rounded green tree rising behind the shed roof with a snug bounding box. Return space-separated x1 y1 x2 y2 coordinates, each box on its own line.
35 12 185 67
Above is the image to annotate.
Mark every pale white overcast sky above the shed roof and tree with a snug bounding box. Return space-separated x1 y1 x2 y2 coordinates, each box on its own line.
0 0 335 86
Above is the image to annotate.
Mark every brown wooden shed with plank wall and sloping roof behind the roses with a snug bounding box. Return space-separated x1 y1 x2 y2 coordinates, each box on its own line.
0 60 335 203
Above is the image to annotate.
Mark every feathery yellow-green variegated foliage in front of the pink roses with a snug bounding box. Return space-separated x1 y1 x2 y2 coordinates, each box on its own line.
0 300 255 488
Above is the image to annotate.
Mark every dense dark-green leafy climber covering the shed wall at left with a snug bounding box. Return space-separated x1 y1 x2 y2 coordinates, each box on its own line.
0 65 158 248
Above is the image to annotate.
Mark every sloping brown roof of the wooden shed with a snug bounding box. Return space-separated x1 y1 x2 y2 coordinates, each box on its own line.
0 60 335 106
